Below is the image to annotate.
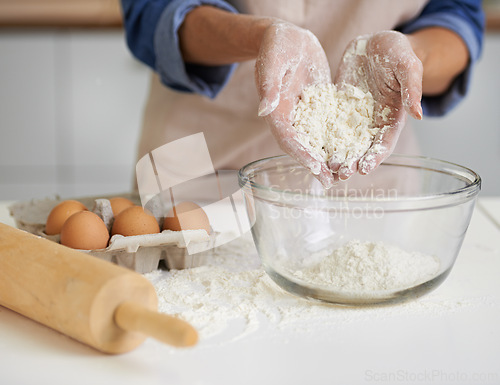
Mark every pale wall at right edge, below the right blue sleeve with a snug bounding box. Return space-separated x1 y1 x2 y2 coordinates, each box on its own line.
412 34 500 196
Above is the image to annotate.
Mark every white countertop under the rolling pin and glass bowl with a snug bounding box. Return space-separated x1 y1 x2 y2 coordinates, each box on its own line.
0 198 500 385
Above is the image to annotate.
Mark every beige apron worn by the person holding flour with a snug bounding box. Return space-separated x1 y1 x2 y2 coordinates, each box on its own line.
138 0 427 169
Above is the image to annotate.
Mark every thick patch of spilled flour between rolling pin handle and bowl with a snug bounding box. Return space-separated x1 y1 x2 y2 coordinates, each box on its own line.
146 236 315 338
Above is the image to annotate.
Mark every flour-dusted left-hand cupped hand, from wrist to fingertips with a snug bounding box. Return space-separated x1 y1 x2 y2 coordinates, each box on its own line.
255 21 336 188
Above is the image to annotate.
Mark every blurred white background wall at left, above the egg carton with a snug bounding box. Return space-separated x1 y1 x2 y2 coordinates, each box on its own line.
0 30 149 199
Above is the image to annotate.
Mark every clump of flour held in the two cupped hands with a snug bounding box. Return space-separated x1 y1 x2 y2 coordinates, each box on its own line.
293 84 378 166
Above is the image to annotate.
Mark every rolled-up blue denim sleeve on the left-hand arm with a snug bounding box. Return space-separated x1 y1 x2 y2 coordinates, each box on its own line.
122 0 237 98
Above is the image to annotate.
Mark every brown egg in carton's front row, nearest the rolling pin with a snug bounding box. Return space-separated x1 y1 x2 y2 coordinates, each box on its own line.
61 211 109 250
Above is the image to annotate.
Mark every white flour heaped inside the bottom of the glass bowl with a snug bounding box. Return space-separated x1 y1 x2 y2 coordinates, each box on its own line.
294 240 439 297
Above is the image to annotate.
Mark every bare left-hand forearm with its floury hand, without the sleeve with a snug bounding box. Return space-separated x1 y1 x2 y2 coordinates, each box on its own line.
179 7 334 187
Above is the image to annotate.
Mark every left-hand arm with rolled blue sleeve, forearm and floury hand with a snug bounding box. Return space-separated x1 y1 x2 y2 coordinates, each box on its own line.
122 0 334 186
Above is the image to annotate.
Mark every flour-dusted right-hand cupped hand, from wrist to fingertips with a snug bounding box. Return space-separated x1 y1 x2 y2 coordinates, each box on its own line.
328 31 423 180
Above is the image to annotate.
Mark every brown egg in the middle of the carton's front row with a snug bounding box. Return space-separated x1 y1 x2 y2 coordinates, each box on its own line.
111 206 160 237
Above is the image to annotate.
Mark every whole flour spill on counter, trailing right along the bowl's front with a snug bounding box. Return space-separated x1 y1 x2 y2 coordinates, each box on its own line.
145 233 489 344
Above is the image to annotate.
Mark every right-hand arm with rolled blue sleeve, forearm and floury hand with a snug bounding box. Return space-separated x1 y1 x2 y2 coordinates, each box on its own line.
330 0 484 179
